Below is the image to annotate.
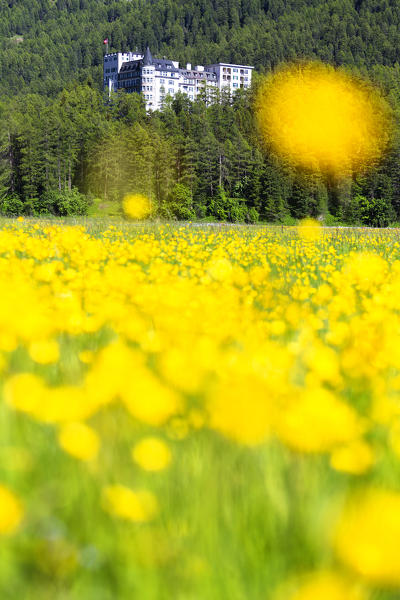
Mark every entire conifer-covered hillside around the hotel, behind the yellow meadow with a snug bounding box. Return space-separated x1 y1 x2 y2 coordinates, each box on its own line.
0 0 400 225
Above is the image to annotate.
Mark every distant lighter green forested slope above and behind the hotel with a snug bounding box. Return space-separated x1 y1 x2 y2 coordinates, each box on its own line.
0 0 400 93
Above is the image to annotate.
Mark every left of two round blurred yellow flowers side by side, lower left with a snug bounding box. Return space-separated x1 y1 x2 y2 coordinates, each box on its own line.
58 422 100 460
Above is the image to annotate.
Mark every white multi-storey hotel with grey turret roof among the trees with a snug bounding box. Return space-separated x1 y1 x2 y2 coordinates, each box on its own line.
103 48 254 110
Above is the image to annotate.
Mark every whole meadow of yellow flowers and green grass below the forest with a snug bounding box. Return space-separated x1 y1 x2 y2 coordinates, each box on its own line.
0 219 400 600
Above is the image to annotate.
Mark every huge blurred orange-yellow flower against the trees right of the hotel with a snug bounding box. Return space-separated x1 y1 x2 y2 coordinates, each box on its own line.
256 63 390 174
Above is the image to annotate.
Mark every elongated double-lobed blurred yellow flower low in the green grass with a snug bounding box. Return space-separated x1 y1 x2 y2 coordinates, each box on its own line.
103 484 159 523
